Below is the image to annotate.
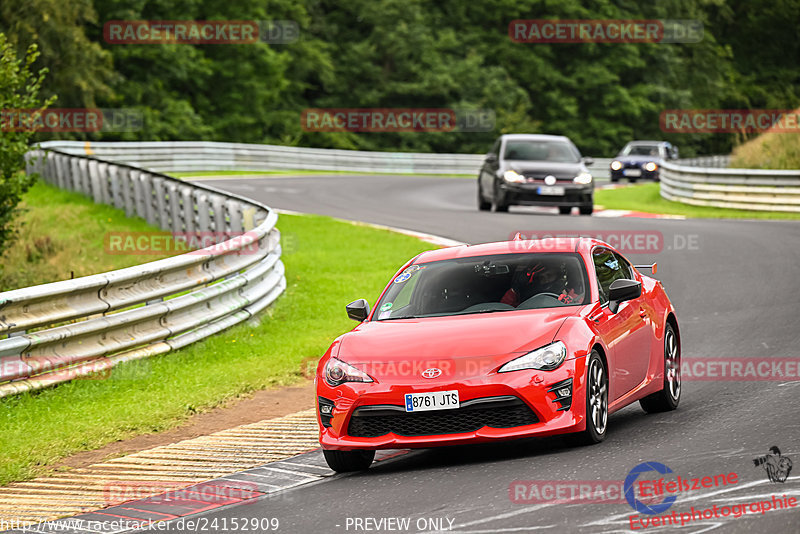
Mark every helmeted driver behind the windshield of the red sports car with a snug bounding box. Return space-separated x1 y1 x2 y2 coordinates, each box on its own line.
500 263 583 308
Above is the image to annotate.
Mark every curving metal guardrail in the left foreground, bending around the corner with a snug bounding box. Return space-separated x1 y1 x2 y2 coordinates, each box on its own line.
0 147 286 397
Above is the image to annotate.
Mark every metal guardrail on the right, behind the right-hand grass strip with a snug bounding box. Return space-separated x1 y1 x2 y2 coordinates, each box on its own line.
660 156 800 212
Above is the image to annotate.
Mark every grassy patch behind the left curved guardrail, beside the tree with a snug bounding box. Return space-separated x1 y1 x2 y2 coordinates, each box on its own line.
0 182 175 291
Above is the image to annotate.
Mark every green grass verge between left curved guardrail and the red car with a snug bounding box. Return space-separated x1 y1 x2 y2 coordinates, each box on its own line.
0 215 433 484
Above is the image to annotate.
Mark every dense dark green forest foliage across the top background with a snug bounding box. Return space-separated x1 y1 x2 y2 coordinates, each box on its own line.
0 0 800 156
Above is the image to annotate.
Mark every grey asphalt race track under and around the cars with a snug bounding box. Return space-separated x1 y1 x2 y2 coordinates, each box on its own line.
158 175 800 533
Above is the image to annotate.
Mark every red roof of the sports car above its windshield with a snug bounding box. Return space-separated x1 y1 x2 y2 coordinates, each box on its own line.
414 237 614 263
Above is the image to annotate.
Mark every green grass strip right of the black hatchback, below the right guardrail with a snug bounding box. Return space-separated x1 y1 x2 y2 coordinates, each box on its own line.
594 183 800 219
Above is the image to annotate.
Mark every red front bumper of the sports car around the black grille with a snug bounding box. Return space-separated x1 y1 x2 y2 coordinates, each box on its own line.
317 356 586 450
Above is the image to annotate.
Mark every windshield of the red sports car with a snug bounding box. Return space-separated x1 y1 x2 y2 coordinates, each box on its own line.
376 253 589 320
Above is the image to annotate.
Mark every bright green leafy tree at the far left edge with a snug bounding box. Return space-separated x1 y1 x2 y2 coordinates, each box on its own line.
0 33 55 252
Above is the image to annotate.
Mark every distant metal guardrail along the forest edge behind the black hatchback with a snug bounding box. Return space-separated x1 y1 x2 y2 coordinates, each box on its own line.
36 141 611 180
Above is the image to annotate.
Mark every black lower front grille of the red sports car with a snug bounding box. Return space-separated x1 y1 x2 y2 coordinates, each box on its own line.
347 396 539 438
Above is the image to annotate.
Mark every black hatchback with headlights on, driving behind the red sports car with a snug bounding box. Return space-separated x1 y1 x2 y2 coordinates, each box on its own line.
478 134 594 215
